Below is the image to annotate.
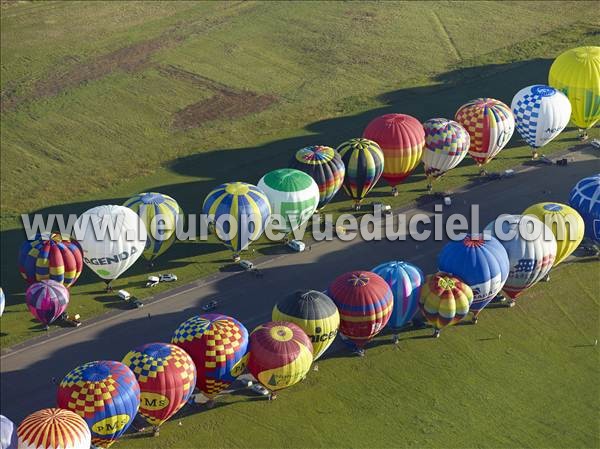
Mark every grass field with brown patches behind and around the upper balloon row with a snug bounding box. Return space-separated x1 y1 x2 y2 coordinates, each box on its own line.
0 2 600 347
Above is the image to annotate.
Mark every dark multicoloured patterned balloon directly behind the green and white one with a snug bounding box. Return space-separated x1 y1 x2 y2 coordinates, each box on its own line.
290 145 346 210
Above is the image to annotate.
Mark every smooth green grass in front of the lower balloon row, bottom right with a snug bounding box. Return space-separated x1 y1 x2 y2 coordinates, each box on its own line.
119 261 600 449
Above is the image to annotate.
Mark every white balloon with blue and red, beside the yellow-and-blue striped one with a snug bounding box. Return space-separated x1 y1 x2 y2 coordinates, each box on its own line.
484 215 556 306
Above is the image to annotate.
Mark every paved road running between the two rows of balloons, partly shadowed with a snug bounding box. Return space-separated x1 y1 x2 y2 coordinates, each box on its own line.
0 151 600 421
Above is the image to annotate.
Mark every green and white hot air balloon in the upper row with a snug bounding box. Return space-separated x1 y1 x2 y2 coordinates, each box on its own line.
258 168 319 235
